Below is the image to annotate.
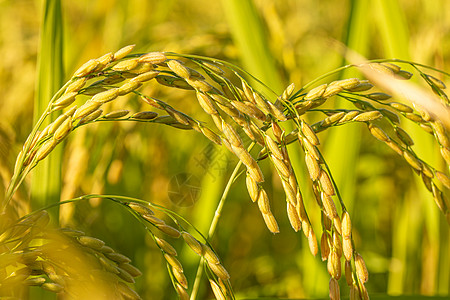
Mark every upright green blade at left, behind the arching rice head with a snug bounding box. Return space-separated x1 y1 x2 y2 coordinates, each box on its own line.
31 0 64 216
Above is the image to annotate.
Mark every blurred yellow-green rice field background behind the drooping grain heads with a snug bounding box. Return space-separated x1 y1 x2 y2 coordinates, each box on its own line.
0 0 450 299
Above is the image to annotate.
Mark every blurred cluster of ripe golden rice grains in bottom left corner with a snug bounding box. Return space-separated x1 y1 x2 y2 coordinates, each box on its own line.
0 211 142 299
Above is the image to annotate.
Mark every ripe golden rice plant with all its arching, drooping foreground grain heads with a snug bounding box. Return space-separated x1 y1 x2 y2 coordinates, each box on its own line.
0 40 450 299
